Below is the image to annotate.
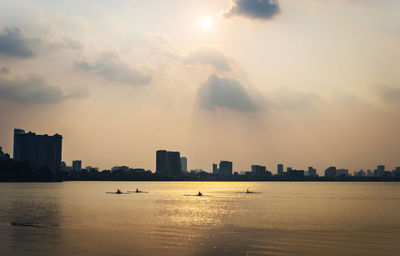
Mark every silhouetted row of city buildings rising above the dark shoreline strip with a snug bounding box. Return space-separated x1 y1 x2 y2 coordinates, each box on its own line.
0 128 400 178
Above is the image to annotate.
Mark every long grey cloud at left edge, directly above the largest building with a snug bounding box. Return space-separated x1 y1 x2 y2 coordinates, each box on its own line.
0 75 89 103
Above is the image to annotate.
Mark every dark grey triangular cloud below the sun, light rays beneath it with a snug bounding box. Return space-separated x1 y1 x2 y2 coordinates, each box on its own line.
197 74 257 111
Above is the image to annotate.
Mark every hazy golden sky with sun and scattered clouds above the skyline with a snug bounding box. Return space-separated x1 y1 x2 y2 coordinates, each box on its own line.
0 0 400 174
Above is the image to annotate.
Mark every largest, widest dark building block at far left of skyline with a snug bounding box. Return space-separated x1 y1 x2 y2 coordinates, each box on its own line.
13 129 62 169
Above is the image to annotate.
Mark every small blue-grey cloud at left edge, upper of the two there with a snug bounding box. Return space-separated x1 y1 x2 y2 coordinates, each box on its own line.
0 28 34 58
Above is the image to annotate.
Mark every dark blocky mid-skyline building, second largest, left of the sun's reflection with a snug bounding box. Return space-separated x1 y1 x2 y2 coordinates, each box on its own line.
156 150 182 176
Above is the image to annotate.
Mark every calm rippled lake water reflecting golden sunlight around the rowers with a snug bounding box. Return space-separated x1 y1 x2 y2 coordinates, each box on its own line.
0 182 400 255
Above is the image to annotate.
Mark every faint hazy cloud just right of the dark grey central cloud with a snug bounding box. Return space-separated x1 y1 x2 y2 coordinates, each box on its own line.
265 88 321 109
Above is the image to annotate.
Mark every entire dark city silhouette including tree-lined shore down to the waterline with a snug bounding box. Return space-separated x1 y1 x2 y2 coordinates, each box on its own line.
0 129 400 181
